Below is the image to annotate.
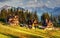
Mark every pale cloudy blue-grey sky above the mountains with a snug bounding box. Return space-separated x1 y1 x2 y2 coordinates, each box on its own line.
0 0 60 8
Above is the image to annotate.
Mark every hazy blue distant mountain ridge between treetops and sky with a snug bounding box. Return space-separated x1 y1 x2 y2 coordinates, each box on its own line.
0 5 60 16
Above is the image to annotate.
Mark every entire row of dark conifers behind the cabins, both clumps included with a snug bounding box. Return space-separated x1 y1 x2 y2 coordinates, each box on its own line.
0 8 60 25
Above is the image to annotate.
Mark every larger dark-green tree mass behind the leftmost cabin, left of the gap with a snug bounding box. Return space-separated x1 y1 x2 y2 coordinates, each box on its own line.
0 8 38 23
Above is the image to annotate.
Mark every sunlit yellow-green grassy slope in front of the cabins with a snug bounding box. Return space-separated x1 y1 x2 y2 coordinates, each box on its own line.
0 24 60 38
